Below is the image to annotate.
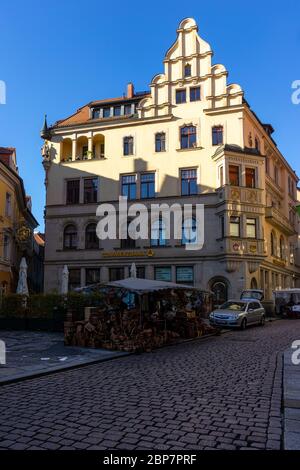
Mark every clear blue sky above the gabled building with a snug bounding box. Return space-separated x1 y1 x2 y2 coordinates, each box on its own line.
0 0 300 229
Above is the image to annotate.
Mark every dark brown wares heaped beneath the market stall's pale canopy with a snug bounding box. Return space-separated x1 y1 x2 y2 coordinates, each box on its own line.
65 308 214 352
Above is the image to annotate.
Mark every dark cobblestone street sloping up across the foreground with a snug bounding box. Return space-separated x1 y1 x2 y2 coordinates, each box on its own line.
0 320 300 450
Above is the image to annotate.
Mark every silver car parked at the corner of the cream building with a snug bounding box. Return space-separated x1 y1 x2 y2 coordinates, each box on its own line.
209 299 266 330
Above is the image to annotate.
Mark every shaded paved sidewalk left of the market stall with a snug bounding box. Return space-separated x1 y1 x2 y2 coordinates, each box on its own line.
0 330 128 385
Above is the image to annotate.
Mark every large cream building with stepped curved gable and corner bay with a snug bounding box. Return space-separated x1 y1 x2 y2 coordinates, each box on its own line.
42 18 300 301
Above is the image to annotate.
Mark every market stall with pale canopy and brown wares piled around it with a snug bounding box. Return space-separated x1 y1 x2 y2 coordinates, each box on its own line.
65 277 214 352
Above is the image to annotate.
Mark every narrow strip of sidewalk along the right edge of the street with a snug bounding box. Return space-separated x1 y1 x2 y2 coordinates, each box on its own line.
283 348 300 450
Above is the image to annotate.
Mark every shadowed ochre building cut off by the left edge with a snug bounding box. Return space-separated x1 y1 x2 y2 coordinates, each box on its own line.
0 147 38 295
